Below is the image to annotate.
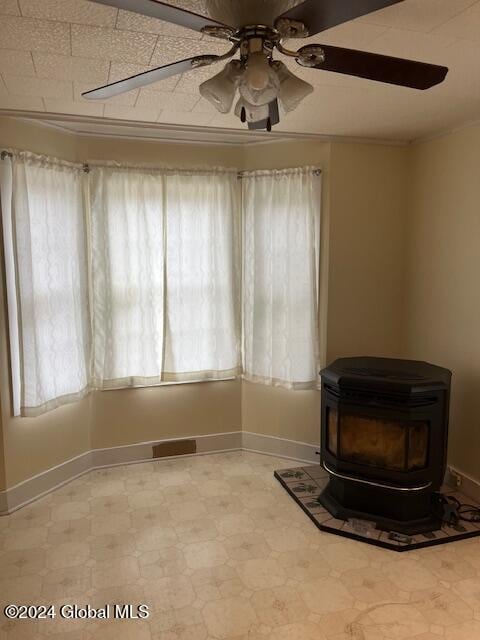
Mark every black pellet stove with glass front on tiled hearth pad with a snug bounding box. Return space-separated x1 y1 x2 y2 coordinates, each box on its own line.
320 357 451 535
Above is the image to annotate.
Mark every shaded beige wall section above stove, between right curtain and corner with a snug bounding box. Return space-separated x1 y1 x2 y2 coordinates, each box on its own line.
327 143 409 361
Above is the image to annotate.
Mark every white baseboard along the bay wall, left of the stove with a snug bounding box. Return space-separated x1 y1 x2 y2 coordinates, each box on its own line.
0 431 318 516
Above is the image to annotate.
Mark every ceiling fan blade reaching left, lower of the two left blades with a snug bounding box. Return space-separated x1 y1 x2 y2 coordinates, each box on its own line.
82 55 224 100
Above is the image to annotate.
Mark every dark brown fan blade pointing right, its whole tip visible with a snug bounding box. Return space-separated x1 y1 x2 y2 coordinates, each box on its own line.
299 44 448 89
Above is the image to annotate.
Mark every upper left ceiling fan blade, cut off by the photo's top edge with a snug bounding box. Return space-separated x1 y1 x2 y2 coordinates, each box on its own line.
93 0 233 31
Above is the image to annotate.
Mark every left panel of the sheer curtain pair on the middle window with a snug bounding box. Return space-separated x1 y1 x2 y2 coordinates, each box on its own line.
89 167 165 389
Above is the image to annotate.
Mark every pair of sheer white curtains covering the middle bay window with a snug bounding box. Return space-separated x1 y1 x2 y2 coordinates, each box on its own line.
89 167 240 389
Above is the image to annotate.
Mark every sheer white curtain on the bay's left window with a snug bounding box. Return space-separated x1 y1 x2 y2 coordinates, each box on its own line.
0 153 90 415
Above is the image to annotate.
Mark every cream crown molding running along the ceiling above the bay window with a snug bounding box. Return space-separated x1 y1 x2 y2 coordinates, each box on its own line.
0 109 410 147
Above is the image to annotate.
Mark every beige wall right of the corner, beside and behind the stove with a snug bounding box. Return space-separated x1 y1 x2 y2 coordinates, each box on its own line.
406 125 480 481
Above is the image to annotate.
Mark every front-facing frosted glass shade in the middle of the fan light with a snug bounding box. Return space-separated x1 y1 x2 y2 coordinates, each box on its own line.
239 53 280 106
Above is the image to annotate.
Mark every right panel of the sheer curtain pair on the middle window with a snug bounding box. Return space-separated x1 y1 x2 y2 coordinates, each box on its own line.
165 171 241 381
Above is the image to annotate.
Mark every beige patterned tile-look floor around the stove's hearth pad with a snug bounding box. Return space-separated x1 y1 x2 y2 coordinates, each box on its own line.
0 452 480 640
